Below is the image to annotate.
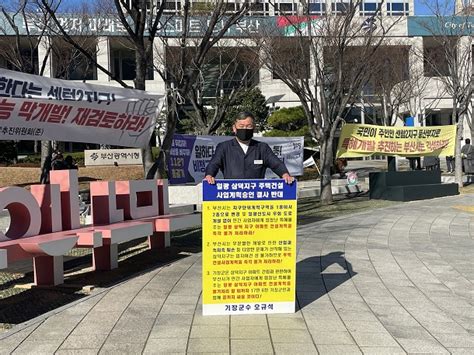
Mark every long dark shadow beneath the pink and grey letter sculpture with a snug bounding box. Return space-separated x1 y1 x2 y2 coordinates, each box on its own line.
0 242 196 332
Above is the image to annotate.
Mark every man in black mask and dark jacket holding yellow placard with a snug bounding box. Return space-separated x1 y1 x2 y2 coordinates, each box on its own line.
205 112 294 184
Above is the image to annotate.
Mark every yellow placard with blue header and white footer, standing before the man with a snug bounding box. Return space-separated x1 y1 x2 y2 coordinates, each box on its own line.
202 179 296 315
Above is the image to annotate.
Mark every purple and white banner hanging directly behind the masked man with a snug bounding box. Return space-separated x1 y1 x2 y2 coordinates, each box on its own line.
167 134 304 184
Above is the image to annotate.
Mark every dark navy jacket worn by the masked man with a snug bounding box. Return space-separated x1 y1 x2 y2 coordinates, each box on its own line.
206 138 288 179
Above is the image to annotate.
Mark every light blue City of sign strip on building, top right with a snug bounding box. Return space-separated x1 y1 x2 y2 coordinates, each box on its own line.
407 16 474 37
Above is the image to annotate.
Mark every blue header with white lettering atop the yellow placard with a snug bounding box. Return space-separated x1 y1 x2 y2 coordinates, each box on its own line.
202 179 297 201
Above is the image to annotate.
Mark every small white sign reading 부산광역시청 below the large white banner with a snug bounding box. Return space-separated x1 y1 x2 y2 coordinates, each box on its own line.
84 149 142 166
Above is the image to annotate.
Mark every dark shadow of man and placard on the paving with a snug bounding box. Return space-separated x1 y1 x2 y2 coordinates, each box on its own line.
296 252 357 309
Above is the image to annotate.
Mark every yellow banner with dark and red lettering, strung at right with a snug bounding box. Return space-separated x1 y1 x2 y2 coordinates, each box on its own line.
337 124 456 158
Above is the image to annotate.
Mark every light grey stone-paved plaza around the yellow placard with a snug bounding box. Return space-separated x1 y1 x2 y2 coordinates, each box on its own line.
0 195 474 354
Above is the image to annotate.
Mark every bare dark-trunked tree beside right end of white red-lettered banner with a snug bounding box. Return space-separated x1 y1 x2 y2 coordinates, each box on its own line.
38 0 248 178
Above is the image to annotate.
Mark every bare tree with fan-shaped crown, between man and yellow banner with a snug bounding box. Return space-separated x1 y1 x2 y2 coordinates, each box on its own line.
256 0 397 204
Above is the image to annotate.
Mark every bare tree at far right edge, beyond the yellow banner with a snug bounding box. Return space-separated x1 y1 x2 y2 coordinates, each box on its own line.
418 0 474 187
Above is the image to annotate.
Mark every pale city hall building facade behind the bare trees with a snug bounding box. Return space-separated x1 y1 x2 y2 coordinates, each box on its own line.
0 0 474 143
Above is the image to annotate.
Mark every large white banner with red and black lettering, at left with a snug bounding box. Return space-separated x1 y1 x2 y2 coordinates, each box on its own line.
0 69 163 147
